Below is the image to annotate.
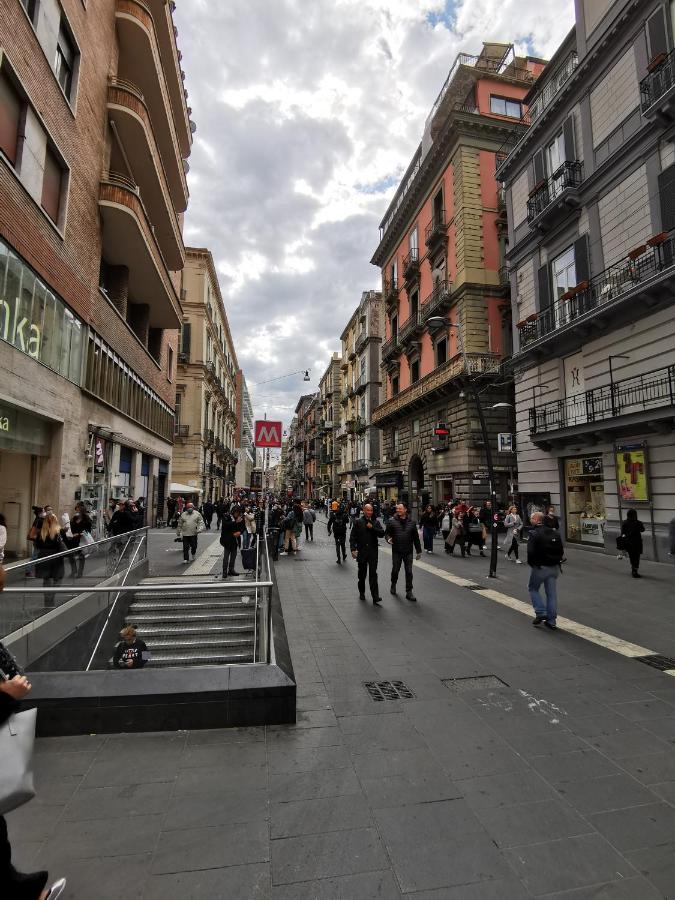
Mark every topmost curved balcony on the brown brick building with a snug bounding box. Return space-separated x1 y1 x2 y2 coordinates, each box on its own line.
115 0 189 212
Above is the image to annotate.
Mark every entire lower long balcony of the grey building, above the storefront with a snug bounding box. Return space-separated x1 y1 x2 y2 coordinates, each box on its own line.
529 358 675 446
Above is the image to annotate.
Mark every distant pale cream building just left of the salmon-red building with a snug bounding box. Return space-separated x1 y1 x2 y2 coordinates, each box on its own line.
336 291 384 500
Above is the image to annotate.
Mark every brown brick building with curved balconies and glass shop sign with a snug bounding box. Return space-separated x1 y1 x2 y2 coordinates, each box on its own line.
0 0 194 540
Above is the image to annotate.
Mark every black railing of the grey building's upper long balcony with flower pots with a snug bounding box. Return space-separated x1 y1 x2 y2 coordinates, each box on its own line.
518 231 675 349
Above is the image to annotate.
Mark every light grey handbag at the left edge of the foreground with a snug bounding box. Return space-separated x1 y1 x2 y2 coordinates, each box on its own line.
0 708 37 815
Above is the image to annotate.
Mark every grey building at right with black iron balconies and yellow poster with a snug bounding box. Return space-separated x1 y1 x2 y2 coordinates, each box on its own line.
498 0 675 559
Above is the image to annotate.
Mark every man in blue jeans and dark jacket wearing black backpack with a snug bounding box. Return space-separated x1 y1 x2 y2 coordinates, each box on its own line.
527 512 565 631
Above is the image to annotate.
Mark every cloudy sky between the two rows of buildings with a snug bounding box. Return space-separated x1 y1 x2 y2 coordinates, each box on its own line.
174 0 574 436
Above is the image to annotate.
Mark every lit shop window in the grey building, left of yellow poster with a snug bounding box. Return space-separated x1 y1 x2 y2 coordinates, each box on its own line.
563 454 607 547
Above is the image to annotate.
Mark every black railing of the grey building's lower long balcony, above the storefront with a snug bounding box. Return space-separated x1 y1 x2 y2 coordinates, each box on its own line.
529 366 675 434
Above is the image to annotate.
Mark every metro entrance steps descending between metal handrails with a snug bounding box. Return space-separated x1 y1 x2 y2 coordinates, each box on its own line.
125 579 259 668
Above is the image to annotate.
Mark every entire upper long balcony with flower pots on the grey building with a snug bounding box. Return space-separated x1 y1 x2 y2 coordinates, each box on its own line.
517 231 675 356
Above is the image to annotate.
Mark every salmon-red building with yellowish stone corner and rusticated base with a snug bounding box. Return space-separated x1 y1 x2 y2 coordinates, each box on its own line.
372 44 542 516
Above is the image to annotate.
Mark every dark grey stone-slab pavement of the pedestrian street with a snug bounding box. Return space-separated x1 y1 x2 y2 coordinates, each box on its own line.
9 526 675 900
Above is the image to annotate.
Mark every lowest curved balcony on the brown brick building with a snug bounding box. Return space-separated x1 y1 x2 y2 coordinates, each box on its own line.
99 172 180 329
